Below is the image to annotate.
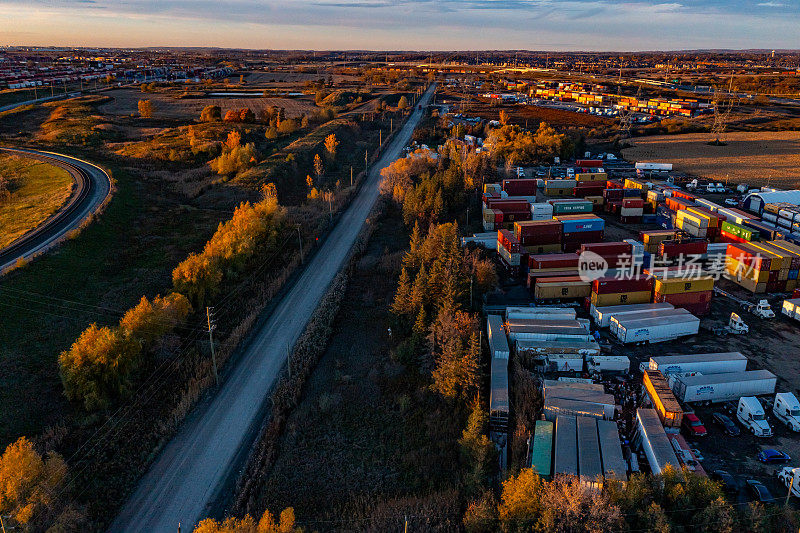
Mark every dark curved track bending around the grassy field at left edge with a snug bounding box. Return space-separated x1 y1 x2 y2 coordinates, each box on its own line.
0 148 111 274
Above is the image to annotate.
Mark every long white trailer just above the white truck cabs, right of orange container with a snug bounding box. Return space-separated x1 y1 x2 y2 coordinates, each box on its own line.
672 370 777 404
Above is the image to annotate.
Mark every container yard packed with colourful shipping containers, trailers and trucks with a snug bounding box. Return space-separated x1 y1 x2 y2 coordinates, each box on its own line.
472 153 800 498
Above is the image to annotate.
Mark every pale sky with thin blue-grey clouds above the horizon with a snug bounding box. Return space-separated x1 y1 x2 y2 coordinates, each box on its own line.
0 0 800 51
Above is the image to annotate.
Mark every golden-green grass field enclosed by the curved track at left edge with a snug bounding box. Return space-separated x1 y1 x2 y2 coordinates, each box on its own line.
0 152 73 248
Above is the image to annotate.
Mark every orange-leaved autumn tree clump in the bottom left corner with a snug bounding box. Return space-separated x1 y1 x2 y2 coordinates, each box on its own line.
0 437 67 530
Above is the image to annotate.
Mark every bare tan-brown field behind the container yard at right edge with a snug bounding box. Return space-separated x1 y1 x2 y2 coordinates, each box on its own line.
622 131 800 188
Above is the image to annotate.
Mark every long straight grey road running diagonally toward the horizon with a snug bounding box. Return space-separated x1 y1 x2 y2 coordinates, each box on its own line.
110 83 433 533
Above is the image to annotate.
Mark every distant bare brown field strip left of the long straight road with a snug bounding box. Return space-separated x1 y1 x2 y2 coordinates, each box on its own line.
98 88 316 118
